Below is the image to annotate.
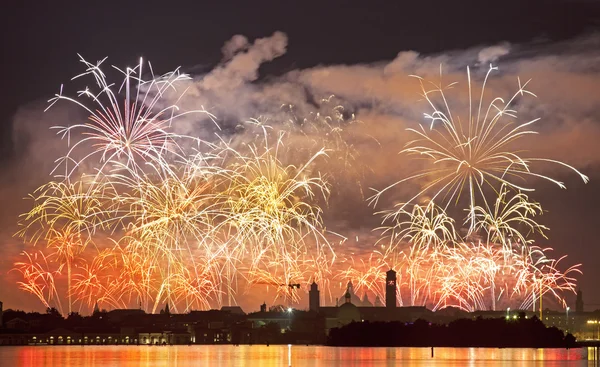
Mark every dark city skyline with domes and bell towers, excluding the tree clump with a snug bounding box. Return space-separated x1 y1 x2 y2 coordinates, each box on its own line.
0 276 600 345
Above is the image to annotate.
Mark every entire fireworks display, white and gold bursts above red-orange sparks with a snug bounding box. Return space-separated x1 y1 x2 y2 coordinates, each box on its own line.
15 59 587 312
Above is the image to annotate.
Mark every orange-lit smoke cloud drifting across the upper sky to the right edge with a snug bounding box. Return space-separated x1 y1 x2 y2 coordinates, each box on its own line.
156 32 600 184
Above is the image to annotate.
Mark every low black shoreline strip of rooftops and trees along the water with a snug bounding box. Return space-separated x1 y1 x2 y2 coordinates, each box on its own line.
0 305 584 353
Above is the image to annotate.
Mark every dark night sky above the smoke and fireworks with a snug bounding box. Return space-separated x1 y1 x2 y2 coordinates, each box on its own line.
0 0 600 314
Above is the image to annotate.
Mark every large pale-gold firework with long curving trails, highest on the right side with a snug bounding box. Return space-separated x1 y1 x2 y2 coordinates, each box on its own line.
371 66 588 231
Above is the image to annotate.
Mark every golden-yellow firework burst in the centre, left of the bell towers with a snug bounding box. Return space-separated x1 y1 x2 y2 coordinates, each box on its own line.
220 121 335 301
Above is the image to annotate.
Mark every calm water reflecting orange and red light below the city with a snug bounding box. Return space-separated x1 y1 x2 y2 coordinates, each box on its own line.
0 345 597 367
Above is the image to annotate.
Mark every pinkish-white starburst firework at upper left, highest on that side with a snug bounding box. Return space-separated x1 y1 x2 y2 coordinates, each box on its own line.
48 56 213 178
